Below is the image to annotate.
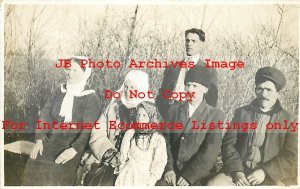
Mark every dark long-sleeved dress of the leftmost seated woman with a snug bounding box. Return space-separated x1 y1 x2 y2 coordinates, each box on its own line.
22 85 100 186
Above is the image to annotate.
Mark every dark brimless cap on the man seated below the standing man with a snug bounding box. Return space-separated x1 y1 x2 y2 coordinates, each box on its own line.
184 64 217 88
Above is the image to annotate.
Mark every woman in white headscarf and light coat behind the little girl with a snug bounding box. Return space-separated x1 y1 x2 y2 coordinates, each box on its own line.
83 70 154 185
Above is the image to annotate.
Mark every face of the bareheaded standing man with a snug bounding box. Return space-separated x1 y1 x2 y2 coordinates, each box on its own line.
185 33 202 56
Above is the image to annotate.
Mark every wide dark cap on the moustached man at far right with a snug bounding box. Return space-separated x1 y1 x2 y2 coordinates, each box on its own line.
255 67 286 91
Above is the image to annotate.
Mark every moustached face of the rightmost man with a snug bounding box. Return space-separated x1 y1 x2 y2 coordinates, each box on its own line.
255 81 278 110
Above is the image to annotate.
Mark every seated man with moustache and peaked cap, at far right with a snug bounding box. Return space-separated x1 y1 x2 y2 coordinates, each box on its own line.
208 67 298 186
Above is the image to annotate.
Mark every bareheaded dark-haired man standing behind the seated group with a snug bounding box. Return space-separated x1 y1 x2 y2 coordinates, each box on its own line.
156 28 218 119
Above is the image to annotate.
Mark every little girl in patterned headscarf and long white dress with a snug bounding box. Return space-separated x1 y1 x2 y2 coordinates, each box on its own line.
115 101 167 186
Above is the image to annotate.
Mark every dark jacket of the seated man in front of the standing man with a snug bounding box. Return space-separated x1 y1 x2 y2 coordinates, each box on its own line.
165 101 225 185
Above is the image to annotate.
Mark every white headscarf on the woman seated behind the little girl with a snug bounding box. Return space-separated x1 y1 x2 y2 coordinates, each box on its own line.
111 70 154 108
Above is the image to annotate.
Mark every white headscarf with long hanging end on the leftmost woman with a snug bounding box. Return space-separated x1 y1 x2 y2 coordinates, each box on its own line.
59 56 95 123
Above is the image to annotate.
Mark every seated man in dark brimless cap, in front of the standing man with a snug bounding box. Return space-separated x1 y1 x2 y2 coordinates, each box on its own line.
156 65 225 186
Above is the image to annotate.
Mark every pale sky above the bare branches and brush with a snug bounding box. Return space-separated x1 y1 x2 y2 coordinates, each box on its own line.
5 3 299 59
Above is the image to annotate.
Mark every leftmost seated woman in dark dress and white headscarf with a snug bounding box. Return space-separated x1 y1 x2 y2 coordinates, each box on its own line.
22 56 100 186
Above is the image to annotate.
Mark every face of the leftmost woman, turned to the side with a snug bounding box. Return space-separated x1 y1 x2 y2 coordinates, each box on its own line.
65 60 84 84
